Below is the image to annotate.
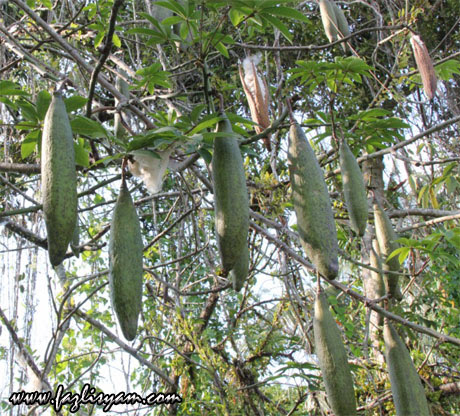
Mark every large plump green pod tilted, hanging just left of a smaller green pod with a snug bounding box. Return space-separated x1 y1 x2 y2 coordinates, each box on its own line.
288 123 339 279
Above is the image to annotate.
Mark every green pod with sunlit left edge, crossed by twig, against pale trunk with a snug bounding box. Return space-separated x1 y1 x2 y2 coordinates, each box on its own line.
374 201 402 300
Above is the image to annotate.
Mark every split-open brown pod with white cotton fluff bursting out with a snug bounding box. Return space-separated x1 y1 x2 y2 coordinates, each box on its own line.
239 54 271 151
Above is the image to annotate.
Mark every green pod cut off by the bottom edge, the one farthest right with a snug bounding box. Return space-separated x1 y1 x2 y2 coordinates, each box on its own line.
383 318 430 416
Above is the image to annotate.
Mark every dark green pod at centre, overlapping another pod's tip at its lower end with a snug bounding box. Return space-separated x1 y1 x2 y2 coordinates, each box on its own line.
212 114 249 272
